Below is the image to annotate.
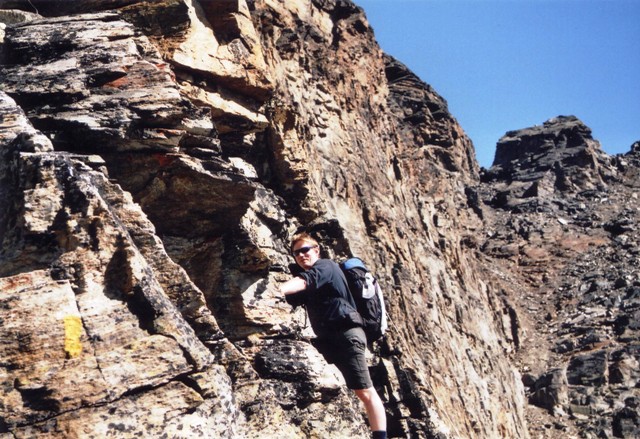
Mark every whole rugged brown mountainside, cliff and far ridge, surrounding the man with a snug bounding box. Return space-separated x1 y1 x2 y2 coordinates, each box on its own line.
0 0 638 438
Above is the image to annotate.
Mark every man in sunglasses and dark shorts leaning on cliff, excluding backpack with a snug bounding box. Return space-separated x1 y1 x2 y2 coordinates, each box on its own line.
280 233 387 439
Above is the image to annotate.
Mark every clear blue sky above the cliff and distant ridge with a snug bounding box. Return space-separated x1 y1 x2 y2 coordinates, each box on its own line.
354 0 640 167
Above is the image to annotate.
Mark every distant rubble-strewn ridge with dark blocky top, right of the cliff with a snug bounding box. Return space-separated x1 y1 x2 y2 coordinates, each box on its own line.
479 116 640 438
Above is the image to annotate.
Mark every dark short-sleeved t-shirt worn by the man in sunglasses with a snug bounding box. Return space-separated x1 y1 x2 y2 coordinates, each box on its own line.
292 259 362 337
